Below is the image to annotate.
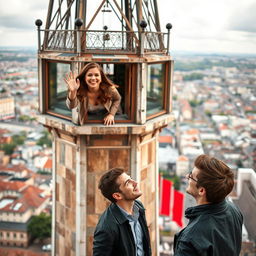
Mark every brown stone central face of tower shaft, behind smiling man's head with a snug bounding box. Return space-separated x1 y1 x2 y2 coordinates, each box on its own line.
86 135 131 255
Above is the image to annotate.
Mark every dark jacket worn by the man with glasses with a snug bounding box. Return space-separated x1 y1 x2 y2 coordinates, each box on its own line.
174 200 243 256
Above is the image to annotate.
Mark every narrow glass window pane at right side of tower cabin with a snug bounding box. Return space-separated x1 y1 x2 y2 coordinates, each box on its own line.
147 63 165 116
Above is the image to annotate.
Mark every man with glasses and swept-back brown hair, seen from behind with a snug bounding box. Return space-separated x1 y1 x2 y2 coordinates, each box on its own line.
174 155 243 256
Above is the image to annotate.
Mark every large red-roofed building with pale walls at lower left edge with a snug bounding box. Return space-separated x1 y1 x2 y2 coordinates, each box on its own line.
0 180 50 247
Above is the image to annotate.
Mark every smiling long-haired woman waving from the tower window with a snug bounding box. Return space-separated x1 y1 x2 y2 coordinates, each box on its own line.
64 62 121 125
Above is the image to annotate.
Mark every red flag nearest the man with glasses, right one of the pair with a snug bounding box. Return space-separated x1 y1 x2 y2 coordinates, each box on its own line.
172 190 185 228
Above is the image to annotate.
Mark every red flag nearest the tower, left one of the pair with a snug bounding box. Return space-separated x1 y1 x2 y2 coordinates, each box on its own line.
159 176 173 217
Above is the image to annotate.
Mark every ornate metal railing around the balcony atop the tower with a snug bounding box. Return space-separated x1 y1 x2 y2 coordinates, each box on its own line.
39 30 168 54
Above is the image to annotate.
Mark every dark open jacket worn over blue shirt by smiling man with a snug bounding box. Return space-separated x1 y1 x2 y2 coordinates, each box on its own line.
93 200 151 256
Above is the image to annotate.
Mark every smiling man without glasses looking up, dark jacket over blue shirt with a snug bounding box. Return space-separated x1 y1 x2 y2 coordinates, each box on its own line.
93 168 151 256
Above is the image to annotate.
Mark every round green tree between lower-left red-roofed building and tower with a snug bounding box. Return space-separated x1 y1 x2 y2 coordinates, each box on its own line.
28 213 51 240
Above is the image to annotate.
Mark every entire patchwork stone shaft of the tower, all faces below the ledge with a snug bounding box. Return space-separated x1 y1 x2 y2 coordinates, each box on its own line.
55 134 158 256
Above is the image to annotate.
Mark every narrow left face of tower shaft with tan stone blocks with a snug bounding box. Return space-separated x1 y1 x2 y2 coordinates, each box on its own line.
55 141 76 256
